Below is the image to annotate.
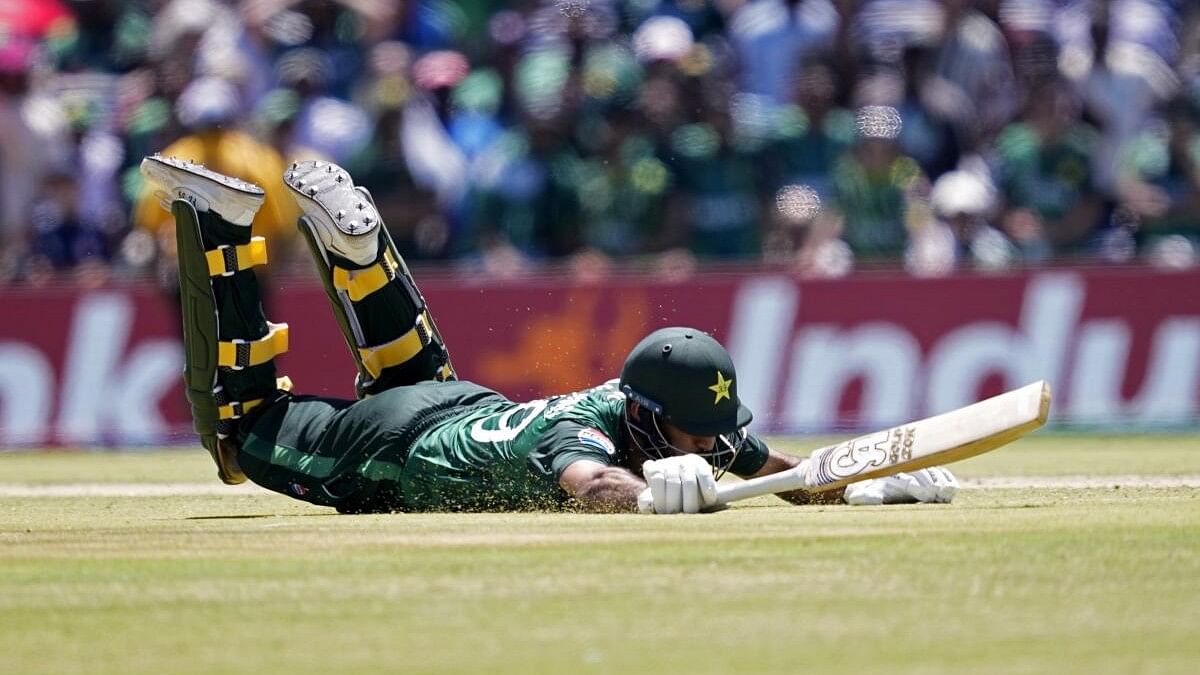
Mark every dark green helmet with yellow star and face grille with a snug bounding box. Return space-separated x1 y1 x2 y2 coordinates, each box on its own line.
620 327 754 468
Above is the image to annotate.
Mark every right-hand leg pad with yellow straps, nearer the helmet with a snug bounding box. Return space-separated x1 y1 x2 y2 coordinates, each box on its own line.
298 187 456 398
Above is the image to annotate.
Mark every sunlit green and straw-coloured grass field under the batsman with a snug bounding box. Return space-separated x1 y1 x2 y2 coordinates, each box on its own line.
0 435 1200 675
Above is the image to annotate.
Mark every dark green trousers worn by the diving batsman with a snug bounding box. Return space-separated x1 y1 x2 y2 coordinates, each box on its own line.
198 211 475 512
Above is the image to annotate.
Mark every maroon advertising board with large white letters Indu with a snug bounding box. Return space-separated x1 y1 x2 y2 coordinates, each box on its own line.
0 268 1200 448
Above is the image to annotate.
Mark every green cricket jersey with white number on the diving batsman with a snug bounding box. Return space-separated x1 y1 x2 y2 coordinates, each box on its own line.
400 381 767 510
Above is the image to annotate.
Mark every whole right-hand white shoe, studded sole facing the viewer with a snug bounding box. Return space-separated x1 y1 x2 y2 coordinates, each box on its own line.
283 161 379 265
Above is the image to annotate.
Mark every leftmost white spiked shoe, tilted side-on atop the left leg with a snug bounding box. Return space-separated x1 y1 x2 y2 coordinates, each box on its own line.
142 155 266 226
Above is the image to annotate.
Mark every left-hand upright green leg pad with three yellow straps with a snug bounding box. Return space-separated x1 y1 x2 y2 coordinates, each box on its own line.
170 199 287 484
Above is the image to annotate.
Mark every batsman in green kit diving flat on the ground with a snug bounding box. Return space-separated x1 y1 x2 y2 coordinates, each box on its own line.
142 155 958 514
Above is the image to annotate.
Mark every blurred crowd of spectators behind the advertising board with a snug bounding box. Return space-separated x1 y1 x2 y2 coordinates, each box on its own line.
0 0 1200 285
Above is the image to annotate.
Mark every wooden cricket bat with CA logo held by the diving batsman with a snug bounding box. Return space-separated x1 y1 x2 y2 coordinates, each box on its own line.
716 381 1050 504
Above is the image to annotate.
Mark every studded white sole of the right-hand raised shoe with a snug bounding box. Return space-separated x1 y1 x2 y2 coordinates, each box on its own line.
283 161 379 237
